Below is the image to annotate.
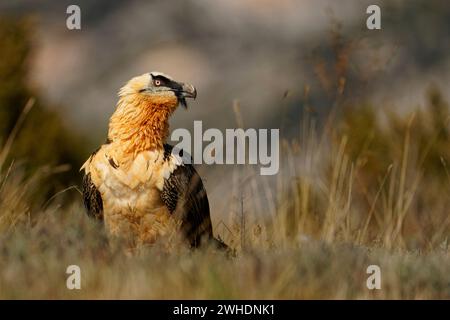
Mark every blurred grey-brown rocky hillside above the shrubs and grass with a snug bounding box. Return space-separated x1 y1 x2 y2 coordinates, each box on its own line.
0 0 450 145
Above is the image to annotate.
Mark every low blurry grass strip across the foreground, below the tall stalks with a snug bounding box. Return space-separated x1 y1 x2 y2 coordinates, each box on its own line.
0 202 450 299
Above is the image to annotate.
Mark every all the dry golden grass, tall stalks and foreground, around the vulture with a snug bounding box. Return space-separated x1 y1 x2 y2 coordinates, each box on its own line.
0 90 450 299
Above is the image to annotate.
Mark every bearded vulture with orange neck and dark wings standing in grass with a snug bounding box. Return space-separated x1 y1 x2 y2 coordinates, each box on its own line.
80 72 226 247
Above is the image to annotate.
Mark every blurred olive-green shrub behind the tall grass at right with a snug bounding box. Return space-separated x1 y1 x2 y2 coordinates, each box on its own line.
337 86 450 184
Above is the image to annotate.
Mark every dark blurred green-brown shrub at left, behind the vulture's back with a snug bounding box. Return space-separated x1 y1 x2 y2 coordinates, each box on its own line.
0 17 86 198
